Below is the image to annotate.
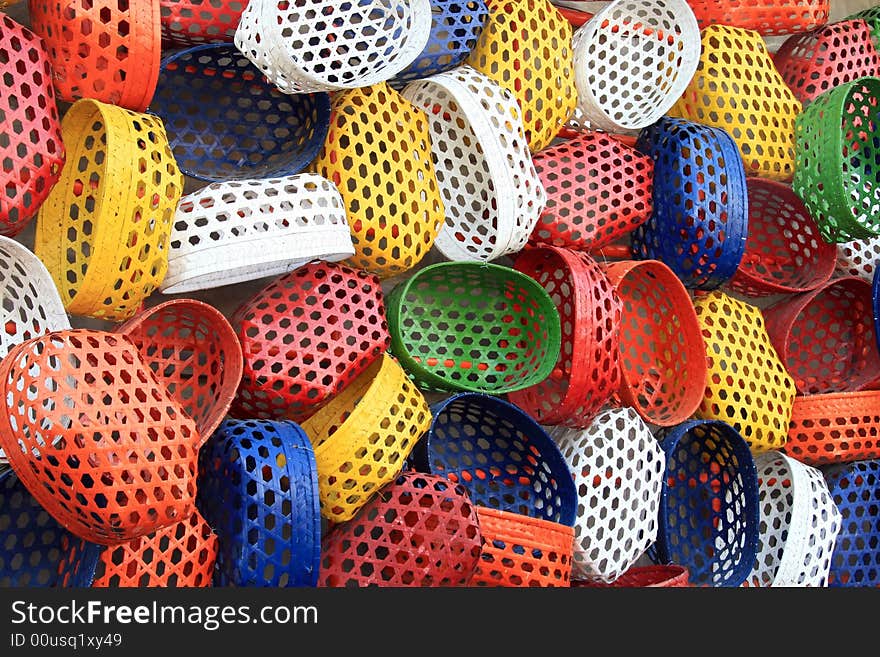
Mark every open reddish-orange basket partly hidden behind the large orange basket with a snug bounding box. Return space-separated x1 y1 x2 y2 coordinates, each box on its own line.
116 299 243 446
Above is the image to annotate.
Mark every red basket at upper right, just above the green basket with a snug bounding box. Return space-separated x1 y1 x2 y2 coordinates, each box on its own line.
773 20 880 105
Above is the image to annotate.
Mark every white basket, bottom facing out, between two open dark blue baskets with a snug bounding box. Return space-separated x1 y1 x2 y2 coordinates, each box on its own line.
548 408 666 582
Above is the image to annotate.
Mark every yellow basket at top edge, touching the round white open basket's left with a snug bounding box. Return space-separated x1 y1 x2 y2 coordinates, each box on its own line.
467 0 577 153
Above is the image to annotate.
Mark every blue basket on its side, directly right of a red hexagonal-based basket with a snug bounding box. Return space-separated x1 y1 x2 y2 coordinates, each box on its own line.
631 118 749 290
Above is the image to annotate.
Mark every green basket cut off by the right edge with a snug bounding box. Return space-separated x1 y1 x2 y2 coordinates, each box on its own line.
792 77 880 242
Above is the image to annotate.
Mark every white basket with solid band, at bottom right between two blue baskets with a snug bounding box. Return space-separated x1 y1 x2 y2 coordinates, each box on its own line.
745 451 841 587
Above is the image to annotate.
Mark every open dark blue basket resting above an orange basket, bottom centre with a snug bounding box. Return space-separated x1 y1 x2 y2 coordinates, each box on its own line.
413 393 577 526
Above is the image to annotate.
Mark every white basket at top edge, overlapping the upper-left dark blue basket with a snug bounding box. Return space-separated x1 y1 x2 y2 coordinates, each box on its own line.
235 0 431 94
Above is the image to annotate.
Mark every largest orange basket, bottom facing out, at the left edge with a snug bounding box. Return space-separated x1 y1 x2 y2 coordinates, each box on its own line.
0 329 199 545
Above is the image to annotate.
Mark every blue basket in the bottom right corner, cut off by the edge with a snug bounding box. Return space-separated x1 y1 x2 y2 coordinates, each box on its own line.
824 460 880 587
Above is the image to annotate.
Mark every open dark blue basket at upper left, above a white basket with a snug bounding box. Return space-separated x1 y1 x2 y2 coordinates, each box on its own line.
147 44 330 182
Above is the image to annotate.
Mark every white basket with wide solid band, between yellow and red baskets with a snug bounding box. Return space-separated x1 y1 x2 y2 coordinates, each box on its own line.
402 66 547 262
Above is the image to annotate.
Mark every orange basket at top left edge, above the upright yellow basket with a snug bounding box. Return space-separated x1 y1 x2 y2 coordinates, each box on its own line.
28 0 161 111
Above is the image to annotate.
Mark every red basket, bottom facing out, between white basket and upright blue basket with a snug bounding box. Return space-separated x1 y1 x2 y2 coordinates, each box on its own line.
529 132 654 251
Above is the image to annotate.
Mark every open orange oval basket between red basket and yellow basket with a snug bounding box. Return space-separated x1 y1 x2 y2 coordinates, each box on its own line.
604 260 706 426
